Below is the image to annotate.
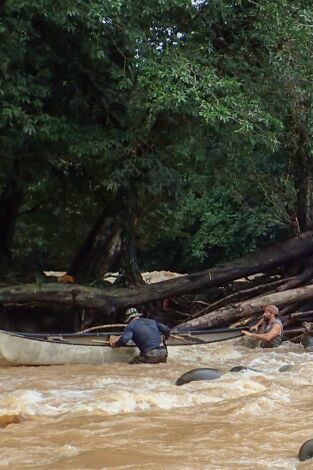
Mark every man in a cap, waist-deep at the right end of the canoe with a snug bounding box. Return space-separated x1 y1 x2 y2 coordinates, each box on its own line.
241 305 284 348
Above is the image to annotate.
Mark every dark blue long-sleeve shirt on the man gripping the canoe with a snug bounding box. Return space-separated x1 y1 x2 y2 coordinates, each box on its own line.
116 318 170 354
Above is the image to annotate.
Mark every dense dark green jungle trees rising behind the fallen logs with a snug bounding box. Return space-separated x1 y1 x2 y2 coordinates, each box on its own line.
0 0 313 278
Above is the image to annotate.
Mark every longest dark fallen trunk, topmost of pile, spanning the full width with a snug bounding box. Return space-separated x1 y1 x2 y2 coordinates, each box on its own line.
0 231 313 313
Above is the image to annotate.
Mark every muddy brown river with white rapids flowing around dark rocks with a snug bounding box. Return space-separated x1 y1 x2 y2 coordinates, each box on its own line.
0 340 313 470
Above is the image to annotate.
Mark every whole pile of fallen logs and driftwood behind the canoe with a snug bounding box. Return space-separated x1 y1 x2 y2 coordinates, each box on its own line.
0 231 313 331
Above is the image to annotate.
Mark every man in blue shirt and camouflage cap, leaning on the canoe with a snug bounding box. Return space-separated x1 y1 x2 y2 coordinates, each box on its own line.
109 308 170 364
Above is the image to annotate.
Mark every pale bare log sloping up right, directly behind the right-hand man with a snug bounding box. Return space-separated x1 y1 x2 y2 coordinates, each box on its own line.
174 285 313 332
